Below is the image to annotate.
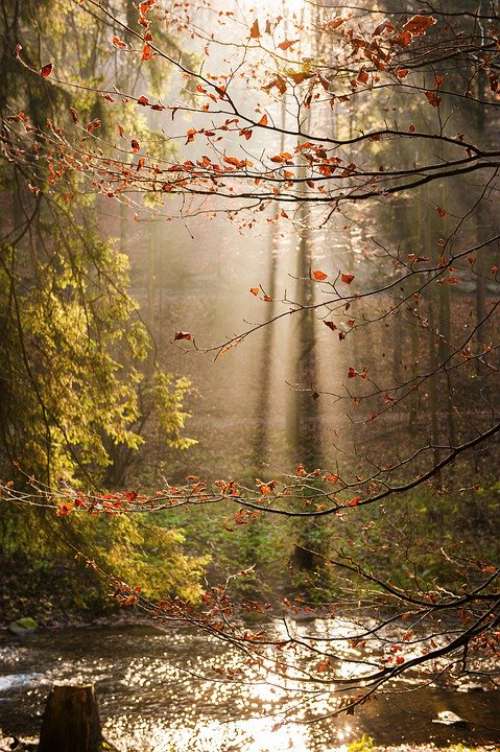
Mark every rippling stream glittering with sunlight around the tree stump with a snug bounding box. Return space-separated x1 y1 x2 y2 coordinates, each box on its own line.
0 626 500 752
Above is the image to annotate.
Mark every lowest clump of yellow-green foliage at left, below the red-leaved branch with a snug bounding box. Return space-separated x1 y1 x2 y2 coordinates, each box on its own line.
0 500 210 618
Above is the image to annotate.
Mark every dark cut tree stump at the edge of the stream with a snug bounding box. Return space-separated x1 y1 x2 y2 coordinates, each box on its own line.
38 684 102 752
